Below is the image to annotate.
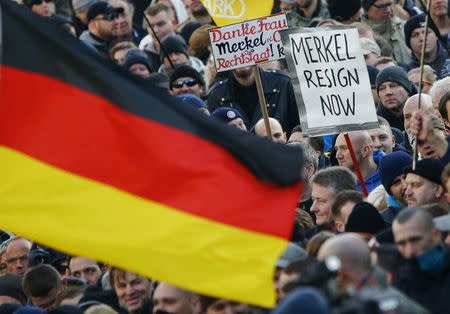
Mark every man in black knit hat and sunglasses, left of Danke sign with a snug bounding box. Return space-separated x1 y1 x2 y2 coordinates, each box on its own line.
170 65 205 97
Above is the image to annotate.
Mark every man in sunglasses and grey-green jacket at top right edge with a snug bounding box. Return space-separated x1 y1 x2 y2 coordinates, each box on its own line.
362 0 411 63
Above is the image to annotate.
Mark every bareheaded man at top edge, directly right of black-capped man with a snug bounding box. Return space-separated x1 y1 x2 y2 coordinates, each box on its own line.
108 0 143 44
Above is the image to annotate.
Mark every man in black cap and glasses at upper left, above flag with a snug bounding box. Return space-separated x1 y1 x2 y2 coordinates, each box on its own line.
80 1 124 56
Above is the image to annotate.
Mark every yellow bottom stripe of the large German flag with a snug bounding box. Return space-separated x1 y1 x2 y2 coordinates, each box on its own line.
0 147 286 306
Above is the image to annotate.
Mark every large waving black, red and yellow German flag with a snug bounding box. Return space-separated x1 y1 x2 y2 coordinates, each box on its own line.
0 0 302 306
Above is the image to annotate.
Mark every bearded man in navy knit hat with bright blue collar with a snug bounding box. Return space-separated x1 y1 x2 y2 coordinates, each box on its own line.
378 151 412 224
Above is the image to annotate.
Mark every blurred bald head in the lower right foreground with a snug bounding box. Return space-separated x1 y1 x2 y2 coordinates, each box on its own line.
317 233 372 282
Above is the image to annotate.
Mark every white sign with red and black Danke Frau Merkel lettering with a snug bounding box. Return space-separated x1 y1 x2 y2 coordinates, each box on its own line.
209 13 288 72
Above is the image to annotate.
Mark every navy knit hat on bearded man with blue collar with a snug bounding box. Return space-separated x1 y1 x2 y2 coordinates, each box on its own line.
378 151 412 195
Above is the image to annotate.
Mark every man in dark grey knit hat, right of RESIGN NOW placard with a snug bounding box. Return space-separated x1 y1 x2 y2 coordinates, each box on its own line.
375 66 416 130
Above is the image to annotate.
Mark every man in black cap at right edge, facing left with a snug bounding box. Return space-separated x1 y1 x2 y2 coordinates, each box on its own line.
405 158 449 209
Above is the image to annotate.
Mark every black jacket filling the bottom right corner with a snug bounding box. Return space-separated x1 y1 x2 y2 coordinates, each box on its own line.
394 245 450 314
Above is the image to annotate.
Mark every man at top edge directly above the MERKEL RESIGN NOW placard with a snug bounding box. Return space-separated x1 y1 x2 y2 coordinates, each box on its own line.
287 0 330 27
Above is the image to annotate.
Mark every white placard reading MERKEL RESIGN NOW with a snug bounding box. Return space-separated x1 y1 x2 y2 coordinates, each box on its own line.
281 26 378 136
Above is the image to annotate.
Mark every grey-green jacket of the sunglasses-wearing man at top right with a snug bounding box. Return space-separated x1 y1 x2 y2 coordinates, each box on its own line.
363 16 411 63
